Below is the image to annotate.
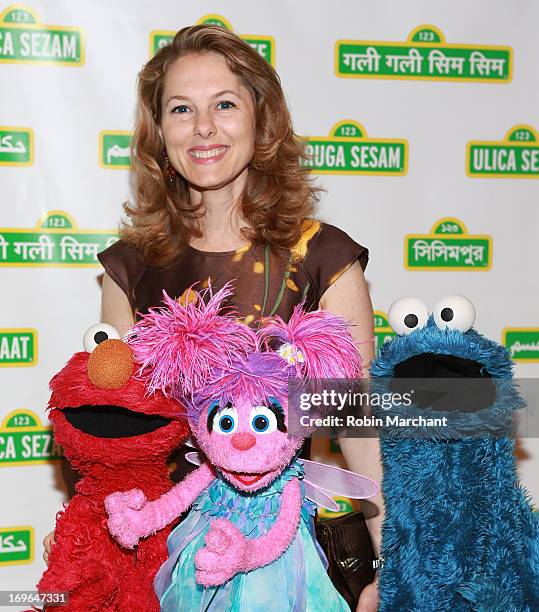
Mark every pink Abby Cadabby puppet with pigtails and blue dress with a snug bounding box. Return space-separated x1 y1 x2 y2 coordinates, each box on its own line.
106 287 378 612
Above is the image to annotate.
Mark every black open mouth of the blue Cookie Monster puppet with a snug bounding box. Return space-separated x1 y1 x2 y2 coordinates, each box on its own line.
390 353 496 412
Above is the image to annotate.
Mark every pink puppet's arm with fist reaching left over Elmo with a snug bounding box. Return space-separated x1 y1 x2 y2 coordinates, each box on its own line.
105 463 215 548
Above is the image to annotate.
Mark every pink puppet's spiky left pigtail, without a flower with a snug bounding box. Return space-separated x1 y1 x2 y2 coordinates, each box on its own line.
127 283 258 397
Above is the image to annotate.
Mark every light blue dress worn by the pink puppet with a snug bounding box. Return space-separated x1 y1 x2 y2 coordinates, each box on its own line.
155 462 350 612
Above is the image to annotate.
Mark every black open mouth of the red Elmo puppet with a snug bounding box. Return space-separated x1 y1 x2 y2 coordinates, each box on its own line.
62 405 171 438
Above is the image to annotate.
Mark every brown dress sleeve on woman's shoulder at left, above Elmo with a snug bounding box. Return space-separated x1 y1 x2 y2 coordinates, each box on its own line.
97 240 146 308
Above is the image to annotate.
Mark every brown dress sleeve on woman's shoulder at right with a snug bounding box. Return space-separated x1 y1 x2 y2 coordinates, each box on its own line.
303 223 369 299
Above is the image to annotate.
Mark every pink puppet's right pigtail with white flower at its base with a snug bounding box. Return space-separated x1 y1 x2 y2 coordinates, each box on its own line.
258 304 362 378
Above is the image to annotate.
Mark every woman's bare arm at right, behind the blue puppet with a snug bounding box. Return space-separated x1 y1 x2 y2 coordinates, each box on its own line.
319 262 384 610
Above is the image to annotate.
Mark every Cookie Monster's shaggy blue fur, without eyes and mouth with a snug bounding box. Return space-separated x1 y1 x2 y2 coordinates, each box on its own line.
371 316 539 612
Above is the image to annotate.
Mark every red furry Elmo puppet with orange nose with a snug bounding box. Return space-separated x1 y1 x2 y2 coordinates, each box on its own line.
38 324 189 612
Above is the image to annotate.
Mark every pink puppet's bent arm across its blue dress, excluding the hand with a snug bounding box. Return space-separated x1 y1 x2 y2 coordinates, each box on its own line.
243 478 303 572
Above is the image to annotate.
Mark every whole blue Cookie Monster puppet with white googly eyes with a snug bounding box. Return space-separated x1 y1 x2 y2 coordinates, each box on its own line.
371 295 539 612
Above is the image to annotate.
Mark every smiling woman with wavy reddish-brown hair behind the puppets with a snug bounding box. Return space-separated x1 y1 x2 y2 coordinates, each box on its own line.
43 26 383 611
